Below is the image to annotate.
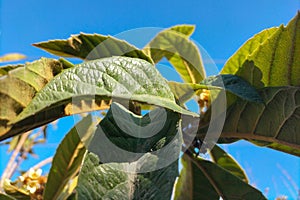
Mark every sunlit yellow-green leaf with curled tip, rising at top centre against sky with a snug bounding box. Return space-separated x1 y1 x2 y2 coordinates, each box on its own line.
144 26 205 83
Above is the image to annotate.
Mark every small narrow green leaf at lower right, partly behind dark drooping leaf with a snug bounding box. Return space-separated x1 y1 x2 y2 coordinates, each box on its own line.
210 145 248 183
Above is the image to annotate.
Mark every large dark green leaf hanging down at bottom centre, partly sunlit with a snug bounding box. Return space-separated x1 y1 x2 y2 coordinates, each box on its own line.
76 103 182 199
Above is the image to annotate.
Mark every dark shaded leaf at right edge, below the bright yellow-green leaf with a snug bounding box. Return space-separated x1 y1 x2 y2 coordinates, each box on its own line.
202 86 300 156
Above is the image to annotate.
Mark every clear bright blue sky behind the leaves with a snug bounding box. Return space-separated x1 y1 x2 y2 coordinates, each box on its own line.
0 0 300 199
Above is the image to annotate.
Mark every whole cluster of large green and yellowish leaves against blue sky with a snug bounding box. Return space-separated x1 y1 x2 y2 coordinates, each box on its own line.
0 13 300 200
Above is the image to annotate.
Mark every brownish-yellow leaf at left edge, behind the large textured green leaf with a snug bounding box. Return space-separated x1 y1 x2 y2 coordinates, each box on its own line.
0 58 64 138
